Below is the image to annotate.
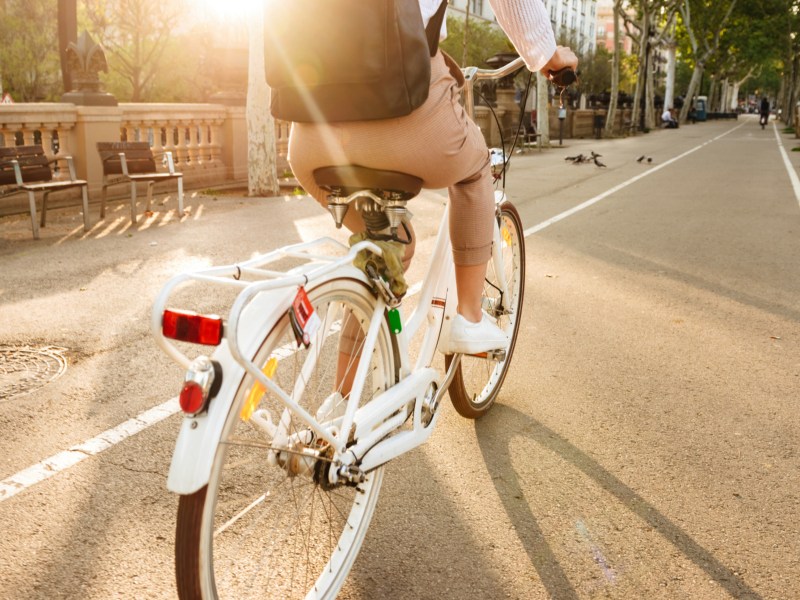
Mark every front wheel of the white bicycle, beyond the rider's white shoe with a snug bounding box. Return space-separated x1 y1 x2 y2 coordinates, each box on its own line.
445 200 525 419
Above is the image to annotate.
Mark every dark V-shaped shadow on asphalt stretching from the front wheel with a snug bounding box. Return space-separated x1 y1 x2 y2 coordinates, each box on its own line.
475 405 761 600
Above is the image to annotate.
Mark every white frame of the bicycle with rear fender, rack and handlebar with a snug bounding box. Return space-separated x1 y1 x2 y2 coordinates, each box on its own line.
157 59 522 494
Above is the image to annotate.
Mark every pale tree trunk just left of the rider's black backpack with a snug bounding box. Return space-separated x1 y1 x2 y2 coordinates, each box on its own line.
246 5 279 196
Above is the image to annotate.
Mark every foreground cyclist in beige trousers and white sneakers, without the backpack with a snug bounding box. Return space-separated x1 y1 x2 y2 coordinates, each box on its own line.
289 0 578 354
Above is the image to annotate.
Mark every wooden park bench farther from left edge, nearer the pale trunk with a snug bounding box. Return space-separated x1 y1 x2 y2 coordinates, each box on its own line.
97 142 183 223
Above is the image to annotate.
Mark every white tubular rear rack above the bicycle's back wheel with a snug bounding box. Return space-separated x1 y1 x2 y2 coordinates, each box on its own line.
150 237 382 369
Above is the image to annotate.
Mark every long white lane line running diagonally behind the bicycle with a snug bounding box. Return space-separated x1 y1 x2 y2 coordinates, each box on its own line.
0 123 752 502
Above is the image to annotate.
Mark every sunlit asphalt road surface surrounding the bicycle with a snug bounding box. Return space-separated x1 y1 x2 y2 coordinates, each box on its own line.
0 117 800 599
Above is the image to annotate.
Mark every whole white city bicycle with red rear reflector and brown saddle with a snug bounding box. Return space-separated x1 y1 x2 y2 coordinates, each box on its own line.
152 60 536 600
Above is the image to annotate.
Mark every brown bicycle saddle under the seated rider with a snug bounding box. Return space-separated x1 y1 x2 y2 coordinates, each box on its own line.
313 165 422 200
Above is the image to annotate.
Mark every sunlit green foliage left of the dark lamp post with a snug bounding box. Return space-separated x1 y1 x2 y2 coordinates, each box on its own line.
0 0 63 102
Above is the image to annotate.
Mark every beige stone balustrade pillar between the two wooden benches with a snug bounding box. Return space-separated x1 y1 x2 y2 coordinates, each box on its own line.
70 106 122 194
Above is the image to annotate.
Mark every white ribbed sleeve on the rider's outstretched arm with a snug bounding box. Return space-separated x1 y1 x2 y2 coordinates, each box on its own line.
489 0 556 71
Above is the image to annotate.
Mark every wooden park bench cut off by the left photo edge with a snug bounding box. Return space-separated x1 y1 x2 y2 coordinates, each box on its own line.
0 146 89 240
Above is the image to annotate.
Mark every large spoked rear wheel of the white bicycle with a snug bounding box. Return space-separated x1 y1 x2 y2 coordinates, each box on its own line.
175 279 394 600
